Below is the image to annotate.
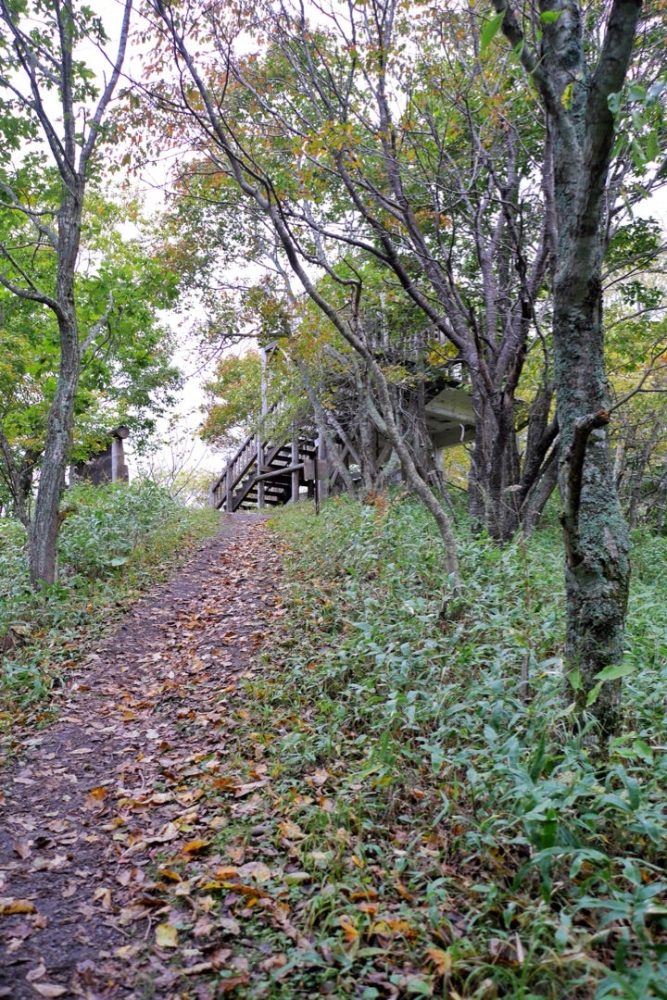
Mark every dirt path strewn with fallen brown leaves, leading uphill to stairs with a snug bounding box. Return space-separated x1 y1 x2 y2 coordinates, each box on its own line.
0 514 280 1000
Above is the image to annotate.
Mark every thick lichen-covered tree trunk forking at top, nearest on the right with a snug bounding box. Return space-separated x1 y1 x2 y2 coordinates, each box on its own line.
494 0 642 734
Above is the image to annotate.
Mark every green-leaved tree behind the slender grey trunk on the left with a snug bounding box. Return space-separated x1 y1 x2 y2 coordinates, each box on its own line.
0 194 179 526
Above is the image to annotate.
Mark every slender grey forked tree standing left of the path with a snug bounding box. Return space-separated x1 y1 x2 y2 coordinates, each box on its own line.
0 0 132 585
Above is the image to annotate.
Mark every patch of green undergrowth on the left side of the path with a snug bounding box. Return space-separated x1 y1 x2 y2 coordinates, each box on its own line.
0 481 219 731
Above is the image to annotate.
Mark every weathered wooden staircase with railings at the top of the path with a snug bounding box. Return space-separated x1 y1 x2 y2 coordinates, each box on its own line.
209 431 317 513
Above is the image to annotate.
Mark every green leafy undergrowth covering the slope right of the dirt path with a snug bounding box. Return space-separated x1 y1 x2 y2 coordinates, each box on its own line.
233 498 667 1000
